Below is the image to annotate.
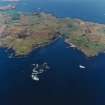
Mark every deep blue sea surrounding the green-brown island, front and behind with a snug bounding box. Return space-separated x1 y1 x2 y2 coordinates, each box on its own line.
0 0 105 105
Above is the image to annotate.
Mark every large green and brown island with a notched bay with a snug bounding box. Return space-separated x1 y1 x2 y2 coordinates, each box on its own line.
0 12 105 57
